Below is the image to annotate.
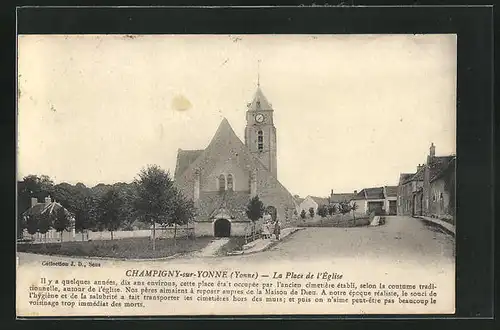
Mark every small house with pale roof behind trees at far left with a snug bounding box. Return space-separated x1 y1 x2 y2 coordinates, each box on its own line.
21 196 75 241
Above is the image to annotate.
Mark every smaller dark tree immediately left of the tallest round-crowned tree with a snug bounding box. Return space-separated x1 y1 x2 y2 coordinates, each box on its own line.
98 188 123 239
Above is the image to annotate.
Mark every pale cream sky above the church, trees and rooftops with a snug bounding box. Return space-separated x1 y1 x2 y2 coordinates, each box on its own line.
17 35 456 197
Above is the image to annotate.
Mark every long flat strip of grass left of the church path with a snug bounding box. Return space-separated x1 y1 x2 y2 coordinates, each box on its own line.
17 237 213 259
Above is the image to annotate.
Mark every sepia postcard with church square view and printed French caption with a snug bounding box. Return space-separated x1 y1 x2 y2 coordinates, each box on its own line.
16 34 457 316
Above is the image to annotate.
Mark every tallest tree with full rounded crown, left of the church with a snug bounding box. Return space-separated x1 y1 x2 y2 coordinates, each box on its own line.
132 165 178 250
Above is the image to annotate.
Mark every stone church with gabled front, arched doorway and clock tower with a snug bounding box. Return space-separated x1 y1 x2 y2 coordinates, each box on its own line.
174 86 296 237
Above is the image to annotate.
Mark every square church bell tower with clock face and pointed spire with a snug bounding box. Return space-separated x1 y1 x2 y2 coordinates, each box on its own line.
245 82 278 178
